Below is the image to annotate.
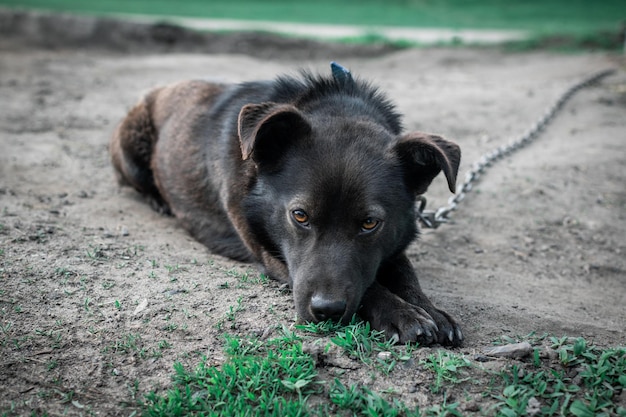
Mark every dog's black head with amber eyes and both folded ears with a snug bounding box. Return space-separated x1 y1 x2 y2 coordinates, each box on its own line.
239 84 460 322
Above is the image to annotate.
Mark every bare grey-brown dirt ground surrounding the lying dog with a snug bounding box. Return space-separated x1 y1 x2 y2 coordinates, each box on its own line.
0 9 626 415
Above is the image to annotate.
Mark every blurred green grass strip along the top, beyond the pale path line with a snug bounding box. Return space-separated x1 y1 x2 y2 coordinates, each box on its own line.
0 0 626 34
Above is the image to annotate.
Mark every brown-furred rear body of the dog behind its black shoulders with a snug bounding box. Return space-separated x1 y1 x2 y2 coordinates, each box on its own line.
110 81 252 262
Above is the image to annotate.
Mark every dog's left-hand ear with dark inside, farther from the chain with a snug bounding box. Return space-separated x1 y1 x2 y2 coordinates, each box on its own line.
238 102 311 165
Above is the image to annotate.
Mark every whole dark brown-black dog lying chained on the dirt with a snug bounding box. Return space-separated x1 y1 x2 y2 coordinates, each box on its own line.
110 62 463 346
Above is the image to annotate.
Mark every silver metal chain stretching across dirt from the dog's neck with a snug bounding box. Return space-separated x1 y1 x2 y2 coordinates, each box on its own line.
417 69 615 229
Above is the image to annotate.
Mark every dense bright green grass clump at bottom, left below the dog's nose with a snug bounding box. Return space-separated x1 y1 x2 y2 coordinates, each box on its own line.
143 332 321 416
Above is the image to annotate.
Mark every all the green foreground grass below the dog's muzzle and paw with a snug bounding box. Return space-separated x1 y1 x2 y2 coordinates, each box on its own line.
139 320 626 417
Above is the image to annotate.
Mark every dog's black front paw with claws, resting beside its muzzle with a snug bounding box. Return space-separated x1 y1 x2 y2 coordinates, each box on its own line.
359 293 463 346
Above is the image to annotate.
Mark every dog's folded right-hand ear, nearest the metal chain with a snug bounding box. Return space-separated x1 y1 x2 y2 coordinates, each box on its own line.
395 132 461 195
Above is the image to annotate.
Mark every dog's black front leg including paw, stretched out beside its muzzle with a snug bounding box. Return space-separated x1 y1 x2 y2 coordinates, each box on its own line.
359 255 463 346
